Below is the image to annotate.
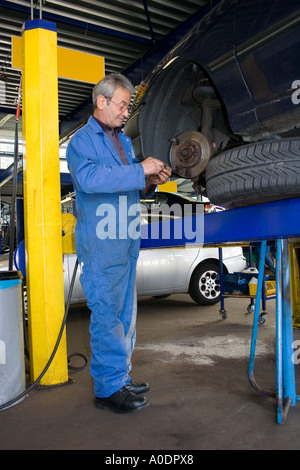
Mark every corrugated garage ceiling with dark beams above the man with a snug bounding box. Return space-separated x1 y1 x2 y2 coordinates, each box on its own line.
0 0 214 198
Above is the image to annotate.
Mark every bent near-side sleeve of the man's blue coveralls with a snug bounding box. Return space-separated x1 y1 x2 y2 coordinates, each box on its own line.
67 131 146 194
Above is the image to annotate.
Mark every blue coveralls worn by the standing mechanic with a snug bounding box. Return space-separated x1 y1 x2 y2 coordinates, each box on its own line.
67 117 146 397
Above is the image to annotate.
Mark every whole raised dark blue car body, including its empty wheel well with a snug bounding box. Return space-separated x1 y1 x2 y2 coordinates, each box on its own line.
125 0 300 203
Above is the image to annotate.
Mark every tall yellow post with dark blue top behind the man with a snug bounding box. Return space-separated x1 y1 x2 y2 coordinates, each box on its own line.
22 20 68 386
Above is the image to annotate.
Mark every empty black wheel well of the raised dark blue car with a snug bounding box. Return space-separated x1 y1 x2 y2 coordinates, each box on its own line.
137 59 231 167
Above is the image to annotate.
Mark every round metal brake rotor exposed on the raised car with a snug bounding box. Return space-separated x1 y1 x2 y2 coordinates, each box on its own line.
170 131 212 179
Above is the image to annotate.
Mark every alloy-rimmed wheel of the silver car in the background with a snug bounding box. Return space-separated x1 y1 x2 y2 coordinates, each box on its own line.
189 264 220 305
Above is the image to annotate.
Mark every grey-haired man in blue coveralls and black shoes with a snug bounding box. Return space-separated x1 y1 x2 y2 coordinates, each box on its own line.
67 74 171 413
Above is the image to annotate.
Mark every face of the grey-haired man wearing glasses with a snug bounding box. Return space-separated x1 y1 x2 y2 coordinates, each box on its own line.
94 88 131 128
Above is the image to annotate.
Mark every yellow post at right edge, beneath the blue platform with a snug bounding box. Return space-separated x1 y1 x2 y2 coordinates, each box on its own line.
289 244 300 328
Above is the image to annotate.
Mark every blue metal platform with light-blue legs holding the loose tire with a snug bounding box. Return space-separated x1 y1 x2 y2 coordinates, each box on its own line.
141 198 300 424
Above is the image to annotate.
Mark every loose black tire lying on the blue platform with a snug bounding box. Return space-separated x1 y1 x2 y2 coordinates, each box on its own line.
206 138 300 209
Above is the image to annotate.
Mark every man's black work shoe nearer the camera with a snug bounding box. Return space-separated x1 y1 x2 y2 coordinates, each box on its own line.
95 387 149 413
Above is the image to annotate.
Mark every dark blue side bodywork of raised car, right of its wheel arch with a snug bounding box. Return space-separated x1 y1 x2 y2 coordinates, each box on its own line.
188 0 300 134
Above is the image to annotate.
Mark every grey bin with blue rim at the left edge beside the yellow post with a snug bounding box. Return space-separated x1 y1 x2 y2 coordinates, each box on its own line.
0 271 26 406
